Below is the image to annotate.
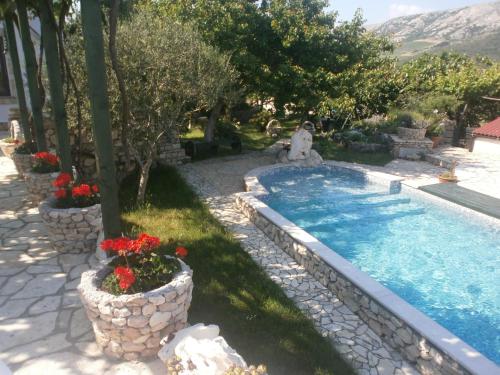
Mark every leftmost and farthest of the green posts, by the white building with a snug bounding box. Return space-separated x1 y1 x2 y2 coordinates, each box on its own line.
5 16 33 143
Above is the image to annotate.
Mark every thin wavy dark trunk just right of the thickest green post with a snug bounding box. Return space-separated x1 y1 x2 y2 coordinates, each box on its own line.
109 0 130 171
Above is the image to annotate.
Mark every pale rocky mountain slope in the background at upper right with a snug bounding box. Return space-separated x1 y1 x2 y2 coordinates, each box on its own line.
370 1 500 61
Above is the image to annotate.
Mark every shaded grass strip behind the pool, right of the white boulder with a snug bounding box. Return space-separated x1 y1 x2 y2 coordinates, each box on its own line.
314 139 393 165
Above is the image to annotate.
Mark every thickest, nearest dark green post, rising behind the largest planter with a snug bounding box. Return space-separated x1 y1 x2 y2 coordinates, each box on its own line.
80 0 121 238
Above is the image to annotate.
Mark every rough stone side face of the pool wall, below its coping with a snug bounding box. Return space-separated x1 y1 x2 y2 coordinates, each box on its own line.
237 193 471 375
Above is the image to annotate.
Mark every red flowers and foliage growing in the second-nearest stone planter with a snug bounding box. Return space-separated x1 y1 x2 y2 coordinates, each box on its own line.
52 172 100 208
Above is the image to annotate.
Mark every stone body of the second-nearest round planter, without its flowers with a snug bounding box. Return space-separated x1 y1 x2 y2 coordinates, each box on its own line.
38 198 102 253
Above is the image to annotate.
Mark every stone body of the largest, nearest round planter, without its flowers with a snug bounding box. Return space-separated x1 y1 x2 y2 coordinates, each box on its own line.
78 261 193 361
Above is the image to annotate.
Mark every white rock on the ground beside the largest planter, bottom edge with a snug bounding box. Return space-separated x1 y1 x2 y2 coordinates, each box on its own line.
158 323 247 375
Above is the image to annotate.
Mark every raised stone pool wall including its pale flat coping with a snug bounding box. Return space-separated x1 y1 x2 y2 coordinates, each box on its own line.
237 162 499 375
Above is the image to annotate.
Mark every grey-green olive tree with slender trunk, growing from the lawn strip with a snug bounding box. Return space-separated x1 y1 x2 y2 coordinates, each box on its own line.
117 10 235 203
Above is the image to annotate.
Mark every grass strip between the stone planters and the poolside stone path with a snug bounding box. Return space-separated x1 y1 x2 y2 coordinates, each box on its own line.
121 168 353 375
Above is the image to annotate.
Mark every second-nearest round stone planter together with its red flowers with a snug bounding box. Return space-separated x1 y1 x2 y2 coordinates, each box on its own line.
38 172 102 253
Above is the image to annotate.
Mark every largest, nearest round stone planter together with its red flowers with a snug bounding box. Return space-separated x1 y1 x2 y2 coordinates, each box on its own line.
78 234 193 360
